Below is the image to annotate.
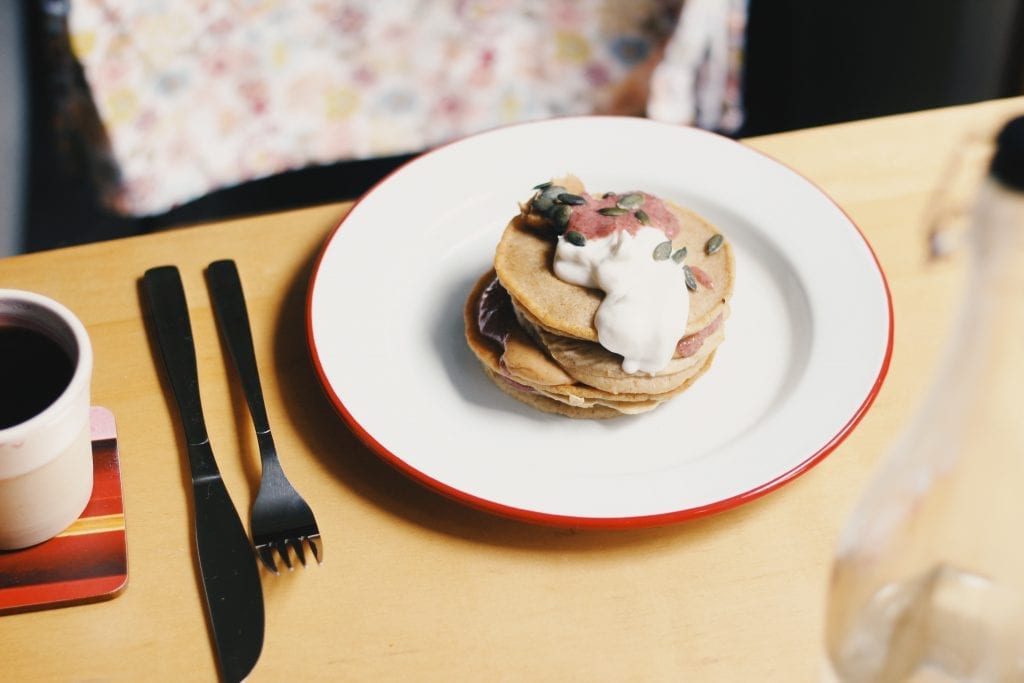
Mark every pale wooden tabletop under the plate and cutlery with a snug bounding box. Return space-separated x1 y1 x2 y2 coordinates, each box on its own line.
0 98 1024 682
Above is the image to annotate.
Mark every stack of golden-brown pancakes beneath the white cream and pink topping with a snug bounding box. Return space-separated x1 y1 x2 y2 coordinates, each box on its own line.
464 176 733 418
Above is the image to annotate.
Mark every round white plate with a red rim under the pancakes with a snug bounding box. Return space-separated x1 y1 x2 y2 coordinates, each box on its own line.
307 117 892 527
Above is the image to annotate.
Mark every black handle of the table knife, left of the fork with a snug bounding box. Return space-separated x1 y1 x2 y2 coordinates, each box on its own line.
142 265 218 479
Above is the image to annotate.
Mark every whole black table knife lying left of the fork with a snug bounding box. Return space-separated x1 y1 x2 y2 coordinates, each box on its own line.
143 265 264 681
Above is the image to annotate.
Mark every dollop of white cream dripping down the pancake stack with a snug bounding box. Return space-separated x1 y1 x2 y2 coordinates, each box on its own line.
554 223 690 375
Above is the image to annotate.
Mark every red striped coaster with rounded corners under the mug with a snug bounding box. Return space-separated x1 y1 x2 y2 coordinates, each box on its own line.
0 407 128 613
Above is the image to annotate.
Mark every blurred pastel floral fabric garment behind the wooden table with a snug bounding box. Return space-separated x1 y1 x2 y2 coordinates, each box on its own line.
69 0 746 215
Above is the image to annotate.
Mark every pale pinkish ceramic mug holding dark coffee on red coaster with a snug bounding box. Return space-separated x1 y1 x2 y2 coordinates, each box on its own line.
0 289 92 550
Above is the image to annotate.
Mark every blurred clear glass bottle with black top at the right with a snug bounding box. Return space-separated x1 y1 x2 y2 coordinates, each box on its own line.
826 117 1024 683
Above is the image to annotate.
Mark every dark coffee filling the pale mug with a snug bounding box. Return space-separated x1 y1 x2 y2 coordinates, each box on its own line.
0 322 75 429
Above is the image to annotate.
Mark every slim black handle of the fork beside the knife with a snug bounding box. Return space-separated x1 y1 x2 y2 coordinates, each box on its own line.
206 259 270 434
